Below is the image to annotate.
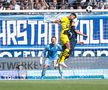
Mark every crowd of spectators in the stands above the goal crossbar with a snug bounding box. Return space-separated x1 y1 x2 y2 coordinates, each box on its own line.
0 0 108 10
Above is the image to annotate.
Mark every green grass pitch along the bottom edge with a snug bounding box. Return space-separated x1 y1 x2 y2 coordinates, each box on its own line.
0 79 108 90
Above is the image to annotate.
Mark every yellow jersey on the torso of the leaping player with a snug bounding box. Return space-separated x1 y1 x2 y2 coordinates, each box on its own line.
60 17 70 35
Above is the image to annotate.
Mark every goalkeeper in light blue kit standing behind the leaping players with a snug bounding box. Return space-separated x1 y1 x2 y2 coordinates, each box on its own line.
40 37 63 79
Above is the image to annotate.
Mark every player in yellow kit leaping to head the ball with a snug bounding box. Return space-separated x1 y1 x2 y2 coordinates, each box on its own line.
51 13 76 67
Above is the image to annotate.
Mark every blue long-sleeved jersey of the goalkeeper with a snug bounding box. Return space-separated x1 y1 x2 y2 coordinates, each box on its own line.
42 44 62 60
